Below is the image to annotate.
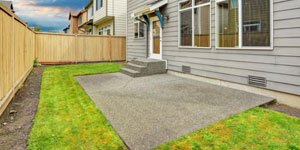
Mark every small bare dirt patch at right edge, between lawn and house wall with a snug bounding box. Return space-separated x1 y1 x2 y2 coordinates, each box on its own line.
266 103 300 118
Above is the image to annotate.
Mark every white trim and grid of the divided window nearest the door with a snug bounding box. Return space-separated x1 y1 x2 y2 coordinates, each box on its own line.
178 0 212 49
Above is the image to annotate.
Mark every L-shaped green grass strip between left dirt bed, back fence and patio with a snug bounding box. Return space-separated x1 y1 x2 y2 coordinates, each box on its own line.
28 63 126 150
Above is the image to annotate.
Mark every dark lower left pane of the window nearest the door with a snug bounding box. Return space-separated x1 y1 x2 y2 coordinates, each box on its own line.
180 9 192 46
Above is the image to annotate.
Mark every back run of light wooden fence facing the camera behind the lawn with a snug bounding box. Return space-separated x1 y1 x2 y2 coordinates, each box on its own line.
35 33 126 64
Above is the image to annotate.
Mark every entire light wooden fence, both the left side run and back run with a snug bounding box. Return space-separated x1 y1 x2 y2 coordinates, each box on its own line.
0 4 126 115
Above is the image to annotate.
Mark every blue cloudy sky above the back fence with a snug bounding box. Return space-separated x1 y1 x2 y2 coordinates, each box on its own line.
14 0 89 31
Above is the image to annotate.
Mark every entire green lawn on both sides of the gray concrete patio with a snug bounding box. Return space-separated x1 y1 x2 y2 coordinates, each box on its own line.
28 63 300 150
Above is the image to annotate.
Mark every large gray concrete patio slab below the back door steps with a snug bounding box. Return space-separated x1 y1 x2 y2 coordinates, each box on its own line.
77 73 273 150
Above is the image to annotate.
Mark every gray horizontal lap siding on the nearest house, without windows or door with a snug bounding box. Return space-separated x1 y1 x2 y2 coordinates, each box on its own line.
127 0 300 95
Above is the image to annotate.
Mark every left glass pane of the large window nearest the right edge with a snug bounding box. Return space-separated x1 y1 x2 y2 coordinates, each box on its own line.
217 0 239 47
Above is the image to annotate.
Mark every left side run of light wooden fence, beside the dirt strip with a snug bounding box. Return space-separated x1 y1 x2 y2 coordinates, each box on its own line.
0 4 35 115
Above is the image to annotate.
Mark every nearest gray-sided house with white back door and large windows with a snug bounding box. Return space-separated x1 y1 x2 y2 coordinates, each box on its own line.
127 0 300 106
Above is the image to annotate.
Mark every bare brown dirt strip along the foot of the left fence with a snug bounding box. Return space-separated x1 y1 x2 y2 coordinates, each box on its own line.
0 67 44 150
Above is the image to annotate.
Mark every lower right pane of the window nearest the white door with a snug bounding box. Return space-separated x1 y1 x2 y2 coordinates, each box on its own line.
194 6 210 47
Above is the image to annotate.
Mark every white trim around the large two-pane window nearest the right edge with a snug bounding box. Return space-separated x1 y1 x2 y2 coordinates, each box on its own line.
215 0 274 50
